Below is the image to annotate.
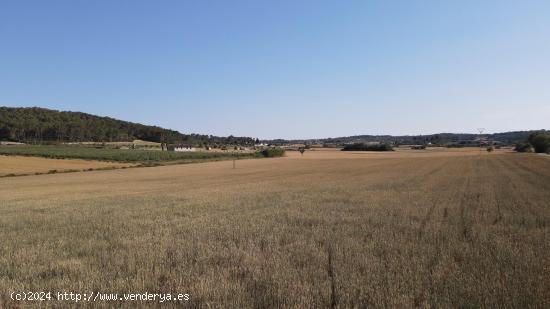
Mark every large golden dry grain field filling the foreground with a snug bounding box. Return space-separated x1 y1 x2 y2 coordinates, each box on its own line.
0 149 550 308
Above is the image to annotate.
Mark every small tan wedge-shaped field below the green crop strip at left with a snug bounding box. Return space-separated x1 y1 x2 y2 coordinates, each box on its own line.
0 155 130 177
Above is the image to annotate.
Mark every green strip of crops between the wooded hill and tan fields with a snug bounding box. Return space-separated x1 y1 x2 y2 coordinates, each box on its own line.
0 145 254 163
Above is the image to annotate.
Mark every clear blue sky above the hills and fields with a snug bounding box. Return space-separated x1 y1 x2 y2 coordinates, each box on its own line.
0 0 550 138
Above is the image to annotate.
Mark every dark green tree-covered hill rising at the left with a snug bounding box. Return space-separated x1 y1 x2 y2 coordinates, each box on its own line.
0 107 255 145
